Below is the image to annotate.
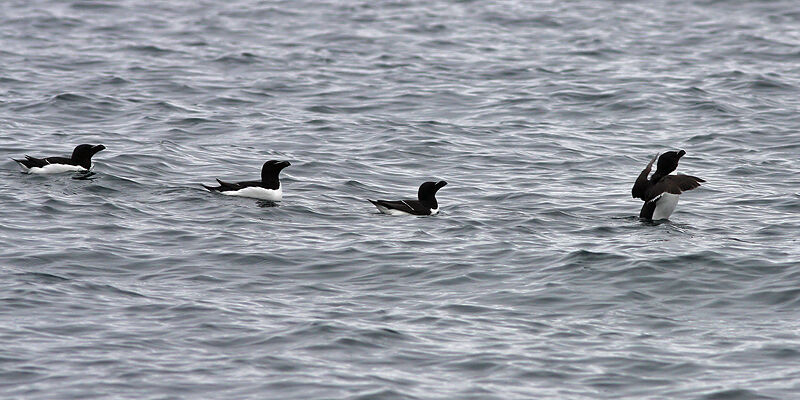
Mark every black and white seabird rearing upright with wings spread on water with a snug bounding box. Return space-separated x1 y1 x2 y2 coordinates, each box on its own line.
631 150 705 220
